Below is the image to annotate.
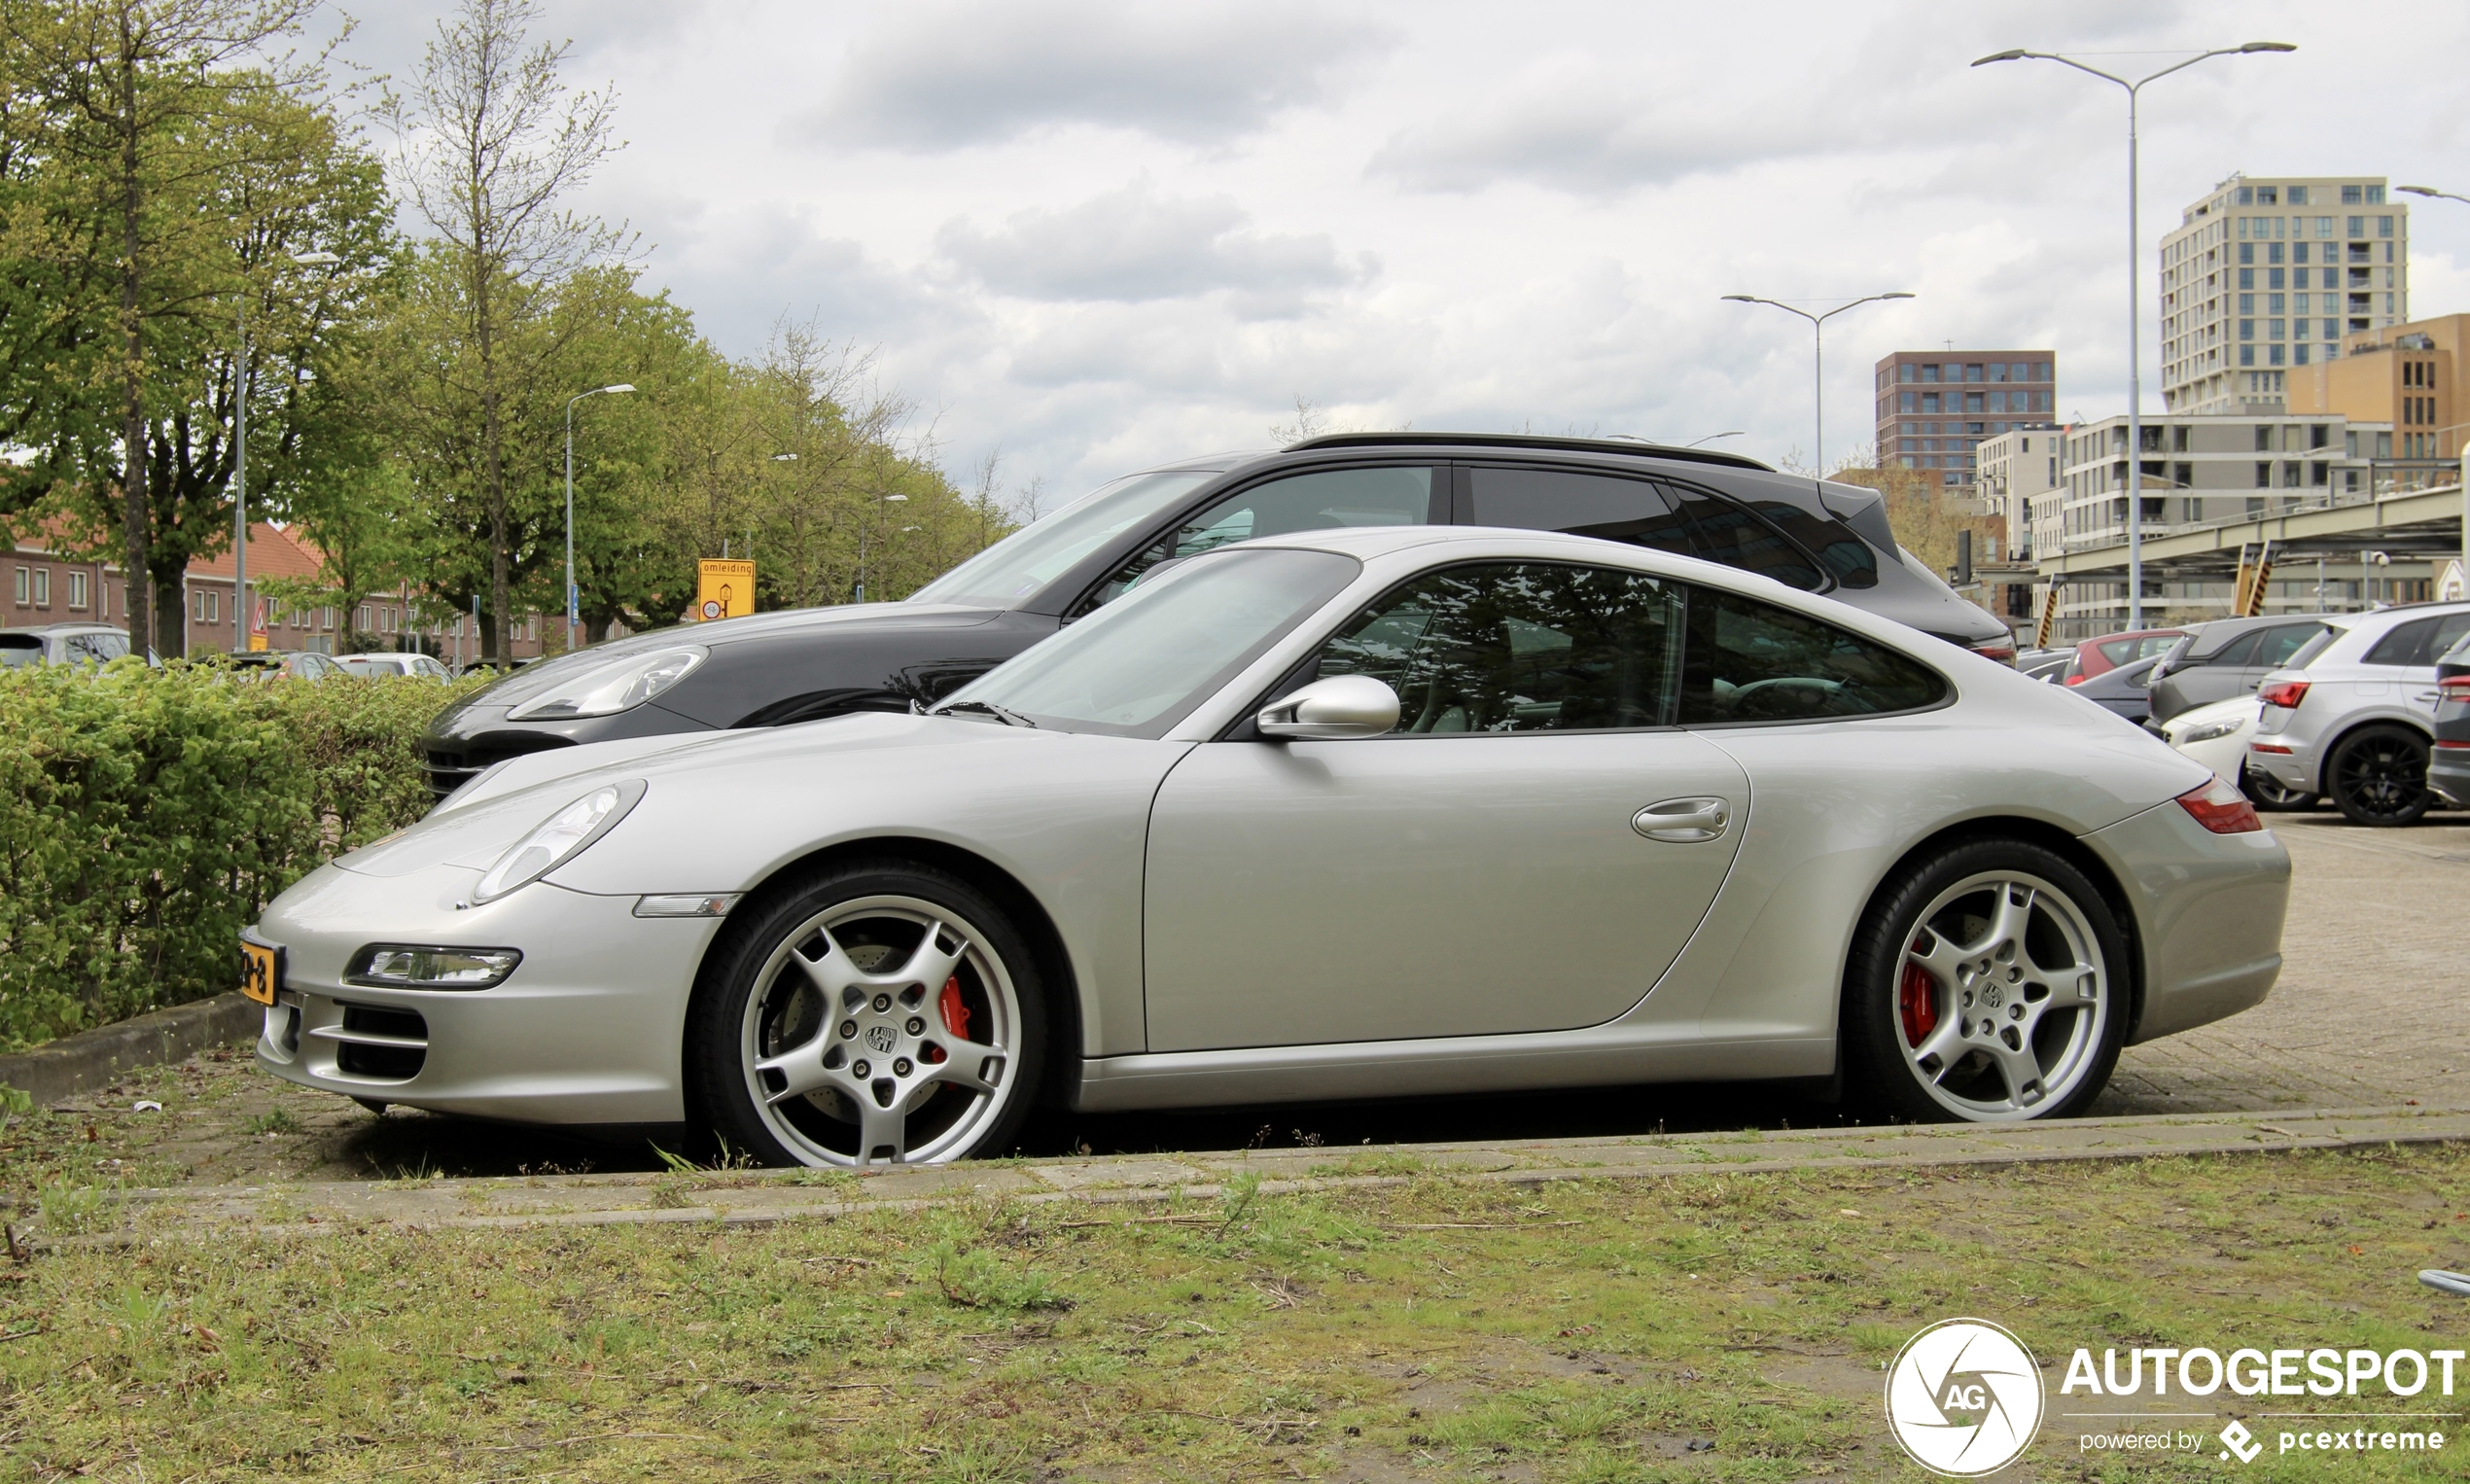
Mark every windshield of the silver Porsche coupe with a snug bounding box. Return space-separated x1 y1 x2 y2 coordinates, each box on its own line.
938 548 1361 736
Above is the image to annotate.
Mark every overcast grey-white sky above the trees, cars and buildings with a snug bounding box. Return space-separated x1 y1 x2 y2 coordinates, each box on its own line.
318 0 2470 509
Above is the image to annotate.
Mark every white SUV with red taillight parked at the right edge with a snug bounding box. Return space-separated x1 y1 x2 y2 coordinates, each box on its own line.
2247 603 2470 825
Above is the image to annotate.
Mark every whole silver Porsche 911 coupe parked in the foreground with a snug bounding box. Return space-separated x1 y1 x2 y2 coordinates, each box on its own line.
244 526 2290 1165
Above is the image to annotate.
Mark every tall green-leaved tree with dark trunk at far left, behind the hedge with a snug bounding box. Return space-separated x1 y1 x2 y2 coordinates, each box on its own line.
0 0 324 647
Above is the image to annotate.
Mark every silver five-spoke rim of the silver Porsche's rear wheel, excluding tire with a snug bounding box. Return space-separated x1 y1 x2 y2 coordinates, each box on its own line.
1894 871 2112 1123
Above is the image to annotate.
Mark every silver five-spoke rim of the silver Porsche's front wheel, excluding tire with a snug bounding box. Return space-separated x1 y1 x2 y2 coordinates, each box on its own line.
741 897 1023 1168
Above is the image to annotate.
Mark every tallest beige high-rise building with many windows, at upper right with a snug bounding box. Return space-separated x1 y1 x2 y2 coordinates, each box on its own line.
2162 175 2411 417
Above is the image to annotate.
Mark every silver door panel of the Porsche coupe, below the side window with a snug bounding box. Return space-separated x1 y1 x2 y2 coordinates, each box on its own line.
1144 731 1748 1052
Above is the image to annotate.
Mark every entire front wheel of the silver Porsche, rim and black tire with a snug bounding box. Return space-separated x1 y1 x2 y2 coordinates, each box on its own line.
689 865 1042 1168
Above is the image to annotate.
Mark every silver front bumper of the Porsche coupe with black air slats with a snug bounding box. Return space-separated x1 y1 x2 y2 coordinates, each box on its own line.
255 866 719 1123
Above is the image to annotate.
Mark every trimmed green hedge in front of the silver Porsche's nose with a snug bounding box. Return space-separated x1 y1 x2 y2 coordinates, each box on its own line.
0 659 479 1049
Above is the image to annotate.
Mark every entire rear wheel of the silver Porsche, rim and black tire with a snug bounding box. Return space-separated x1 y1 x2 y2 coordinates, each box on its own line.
1845 839 2127 1123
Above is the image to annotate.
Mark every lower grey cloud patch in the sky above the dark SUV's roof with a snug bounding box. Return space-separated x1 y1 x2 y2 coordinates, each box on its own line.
936 183 1376 303
